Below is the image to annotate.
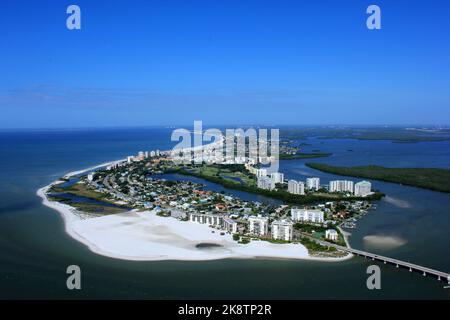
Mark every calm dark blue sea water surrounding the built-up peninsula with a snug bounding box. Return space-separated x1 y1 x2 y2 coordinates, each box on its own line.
0 129 450 299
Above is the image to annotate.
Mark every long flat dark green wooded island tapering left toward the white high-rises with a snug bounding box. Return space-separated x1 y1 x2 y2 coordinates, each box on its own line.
306 163 450 193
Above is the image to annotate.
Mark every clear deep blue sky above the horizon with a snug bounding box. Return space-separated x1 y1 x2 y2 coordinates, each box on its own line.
0 0 450 128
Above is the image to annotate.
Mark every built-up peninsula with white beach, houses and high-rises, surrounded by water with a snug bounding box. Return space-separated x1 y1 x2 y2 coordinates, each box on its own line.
38 141 382 261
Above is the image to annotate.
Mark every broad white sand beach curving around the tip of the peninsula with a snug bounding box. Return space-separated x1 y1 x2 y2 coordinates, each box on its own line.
37 161 352 261
